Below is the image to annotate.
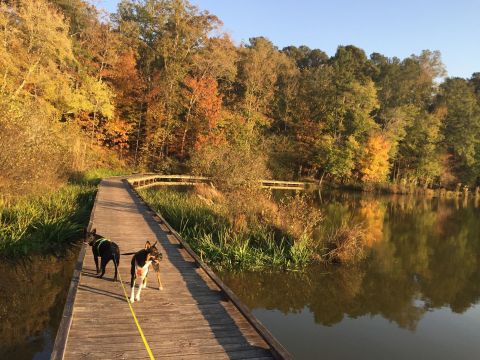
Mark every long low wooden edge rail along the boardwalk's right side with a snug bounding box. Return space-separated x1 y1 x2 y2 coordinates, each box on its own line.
126 178 293 360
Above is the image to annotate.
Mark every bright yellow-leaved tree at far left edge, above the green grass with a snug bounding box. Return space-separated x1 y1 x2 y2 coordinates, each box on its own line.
0 0 76 186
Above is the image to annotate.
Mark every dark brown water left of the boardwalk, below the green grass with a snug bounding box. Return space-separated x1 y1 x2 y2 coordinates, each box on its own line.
0 252 76 360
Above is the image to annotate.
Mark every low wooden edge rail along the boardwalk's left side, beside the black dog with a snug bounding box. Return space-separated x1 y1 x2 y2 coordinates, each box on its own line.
50 189 100 360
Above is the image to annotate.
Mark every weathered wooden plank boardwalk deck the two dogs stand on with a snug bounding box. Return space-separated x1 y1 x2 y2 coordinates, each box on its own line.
52 178 290 359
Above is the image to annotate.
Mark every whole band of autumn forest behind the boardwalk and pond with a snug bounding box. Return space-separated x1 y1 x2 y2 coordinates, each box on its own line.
0 0 480 192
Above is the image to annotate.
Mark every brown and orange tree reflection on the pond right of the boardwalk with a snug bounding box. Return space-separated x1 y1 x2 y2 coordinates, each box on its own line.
222 193 480 359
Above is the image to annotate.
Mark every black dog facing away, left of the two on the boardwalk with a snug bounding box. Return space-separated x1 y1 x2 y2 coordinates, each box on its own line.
85 229 120 281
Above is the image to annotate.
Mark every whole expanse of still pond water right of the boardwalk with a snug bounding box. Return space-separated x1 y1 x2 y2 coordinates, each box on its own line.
222 193 480 360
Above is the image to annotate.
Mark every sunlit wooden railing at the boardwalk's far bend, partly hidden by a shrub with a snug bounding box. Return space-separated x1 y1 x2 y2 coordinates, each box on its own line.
128 174 315 190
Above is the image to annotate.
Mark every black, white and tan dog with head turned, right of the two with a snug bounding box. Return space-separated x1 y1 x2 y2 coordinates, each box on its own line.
130 241 163 303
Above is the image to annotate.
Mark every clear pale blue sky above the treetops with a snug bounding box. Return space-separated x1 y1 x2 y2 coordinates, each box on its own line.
97 0 480 77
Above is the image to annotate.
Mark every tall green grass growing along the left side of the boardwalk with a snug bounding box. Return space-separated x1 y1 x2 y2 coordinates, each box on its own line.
0 169 131 258
